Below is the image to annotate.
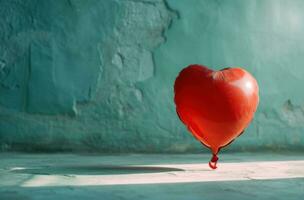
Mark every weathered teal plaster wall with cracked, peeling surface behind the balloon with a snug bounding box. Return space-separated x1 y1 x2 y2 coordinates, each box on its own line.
0 0 304 152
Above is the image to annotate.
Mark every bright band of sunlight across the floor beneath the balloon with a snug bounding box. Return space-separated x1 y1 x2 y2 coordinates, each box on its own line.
18 160 304 187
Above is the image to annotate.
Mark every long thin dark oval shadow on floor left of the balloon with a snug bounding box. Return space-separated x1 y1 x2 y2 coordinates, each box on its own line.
11 165 184 175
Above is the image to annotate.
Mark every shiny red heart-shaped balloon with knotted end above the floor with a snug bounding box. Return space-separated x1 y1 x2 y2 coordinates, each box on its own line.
174 65 259 168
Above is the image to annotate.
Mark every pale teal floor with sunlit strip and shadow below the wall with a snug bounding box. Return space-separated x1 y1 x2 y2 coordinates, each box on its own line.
0 153 304 200
